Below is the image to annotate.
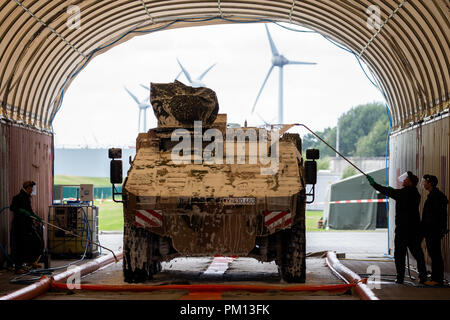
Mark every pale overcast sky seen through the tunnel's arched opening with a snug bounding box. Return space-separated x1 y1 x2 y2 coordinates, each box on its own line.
53 23 384 148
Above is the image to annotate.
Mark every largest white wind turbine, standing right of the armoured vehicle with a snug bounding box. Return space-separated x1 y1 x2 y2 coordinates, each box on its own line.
252 24 316 124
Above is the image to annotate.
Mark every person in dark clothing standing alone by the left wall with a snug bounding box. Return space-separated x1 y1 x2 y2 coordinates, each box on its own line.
9 181 43 274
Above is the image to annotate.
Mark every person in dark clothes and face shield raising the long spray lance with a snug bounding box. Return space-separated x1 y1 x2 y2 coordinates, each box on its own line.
367 171 427 283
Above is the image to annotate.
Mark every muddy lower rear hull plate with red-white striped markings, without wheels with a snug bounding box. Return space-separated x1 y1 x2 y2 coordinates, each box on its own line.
124 194 304 256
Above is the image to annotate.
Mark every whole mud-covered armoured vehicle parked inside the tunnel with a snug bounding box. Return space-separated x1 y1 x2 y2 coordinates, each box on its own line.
110 81 314 282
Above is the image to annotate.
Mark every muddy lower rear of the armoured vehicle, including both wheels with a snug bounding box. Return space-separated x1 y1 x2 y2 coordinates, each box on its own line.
123 193 306 282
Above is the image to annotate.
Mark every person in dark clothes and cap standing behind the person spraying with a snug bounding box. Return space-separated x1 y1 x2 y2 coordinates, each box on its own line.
422 174 448 286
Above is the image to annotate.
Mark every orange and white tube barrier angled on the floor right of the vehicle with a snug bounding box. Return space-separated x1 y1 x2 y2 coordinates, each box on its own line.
326 251 379 300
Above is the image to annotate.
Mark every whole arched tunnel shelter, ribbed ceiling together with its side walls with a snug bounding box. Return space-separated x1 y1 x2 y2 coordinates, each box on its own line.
0 0 450 273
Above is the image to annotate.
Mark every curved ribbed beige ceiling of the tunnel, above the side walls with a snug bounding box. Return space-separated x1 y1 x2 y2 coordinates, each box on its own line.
0 0 450 130
